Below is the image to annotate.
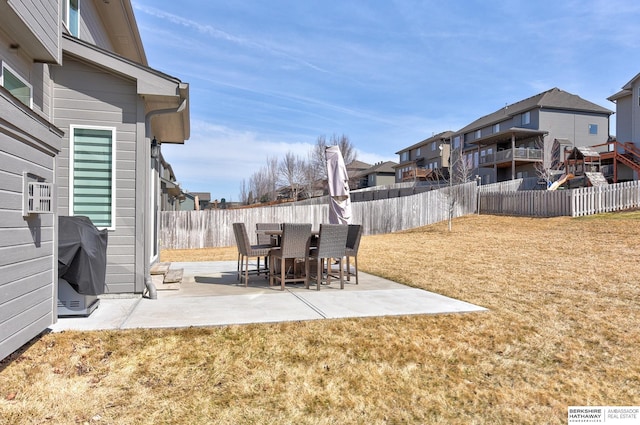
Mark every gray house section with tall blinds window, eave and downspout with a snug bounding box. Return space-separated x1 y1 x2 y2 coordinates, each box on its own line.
50 0 189 293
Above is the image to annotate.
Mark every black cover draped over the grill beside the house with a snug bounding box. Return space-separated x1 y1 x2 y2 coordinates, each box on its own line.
58 216 108 295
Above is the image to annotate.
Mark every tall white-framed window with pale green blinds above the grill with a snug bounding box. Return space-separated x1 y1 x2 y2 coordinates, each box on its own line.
69 126 116 229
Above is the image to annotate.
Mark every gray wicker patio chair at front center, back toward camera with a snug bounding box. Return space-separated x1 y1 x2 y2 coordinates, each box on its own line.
269 223 311 291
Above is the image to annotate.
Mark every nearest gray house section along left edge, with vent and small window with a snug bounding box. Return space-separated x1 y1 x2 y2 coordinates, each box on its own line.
0 0 63 359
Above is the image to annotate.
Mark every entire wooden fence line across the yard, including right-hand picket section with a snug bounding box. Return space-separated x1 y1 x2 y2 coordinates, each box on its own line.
160 180 640 249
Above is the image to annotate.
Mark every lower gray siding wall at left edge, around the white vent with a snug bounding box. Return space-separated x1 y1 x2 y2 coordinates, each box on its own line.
0 94 61 359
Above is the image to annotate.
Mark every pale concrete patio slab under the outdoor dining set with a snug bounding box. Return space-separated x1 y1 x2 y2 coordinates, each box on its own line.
50 261 486 332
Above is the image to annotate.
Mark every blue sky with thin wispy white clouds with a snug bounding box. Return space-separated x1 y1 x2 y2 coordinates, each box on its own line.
132 0 640 201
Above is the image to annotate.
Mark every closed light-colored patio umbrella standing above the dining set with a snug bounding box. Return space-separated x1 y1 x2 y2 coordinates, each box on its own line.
325 146 351 224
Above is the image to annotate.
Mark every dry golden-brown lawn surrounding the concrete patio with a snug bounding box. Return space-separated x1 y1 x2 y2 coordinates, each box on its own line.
0 213 640 424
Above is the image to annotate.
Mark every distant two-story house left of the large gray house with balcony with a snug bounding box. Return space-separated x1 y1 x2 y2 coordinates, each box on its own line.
395 131 453 183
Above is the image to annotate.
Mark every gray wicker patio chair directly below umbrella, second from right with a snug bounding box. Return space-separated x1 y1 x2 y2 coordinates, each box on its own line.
307 224 349 291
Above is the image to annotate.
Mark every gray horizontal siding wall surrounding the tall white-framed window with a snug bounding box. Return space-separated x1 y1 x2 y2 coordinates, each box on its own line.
52 56 143 293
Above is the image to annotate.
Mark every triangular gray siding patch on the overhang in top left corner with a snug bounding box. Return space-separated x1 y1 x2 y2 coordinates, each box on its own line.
8 0 61 62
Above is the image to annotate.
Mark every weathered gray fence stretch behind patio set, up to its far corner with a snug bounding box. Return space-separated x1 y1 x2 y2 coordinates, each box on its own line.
160 183 477 249
